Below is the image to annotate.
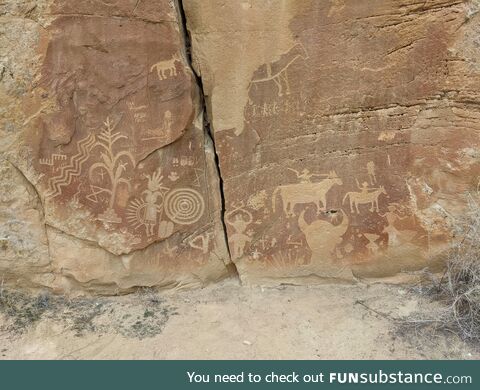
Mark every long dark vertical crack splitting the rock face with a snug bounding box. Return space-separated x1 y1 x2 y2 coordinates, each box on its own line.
176 0 239 277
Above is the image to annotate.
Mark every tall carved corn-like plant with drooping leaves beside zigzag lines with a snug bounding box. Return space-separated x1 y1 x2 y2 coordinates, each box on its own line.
87 118 135 224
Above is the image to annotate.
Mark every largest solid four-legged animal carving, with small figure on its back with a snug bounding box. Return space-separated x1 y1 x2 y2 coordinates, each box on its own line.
272 170 343 216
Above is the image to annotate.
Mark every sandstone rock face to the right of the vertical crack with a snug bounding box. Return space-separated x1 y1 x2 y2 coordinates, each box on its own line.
184 0 480 283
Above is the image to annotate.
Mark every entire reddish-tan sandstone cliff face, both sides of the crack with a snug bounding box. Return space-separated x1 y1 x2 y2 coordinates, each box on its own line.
0 0 480 293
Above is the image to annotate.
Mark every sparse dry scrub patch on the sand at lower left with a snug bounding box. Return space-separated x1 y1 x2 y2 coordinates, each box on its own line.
0 286 176 339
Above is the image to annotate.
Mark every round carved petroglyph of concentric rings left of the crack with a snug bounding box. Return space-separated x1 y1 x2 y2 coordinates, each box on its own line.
164 188 205 225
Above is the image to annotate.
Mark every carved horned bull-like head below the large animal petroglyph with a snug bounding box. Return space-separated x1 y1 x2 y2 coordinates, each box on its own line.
298 210 350 257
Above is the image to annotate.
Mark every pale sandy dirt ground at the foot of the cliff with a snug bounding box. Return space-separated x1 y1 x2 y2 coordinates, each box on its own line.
0 280 480 359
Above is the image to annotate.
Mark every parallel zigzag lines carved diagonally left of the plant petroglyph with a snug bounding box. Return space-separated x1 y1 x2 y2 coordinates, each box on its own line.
46 133 96 198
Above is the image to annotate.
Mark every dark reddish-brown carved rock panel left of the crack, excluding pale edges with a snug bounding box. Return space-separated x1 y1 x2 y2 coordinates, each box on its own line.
12 0 228 273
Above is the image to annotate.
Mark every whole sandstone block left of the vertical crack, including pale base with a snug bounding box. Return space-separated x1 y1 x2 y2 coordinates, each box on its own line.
1 0 229 292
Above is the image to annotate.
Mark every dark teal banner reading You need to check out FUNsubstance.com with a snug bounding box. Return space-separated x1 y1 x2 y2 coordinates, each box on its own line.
0 361 480 390
